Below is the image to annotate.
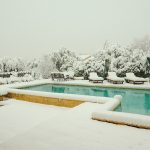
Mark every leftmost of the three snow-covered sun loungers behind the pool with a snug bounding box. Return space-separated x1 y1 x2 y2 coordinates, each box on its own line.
89 72 104 83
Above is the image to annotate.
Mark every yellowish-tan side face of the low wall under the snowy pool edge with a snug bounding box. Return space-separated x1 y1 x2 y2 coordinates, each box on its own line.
6 93 83 108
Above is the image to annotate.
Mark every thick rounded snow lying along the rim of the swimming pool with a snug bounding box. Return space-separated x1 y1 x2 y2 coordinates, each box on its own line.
1 80 150 131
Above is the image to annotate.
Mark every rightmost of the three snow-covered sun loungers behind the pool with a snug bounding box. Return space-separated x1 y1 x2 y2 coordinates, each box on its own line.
125 73 147 84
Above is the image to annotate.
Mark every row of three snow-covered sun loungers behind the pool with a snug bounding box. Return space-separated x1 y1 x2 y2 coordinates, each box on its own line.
89 72 147 84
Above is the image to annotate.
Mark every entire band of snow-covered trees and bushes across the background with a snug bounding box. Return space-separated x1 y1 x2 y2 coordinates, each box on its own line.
0 37 150 80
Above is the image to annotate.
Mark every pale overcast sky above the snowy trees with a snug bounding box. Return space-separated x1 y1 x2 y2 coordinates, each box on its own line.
0 0 150 58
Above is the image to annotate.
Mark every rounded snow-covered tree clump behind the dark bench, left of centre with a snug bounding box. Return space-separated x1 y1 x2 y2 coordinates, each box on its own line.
36 48 78 79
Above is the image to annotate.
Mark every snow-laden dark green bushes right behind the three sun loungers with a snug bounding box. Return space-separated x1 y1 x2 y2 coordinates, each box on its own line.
73 42 150 78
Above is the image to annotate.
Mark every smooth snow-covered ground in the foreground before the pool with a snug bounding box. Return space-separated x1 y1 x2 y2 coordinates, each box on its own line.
0 100 150 150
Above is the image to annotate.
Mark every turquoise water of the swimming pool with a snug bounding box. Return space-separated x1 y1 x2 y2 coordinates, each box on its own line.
20 84 150 115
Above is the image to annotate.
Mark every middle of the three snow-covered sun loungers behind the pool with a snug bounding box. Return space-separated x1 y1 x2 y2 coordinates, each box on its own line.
107 72 124 84
